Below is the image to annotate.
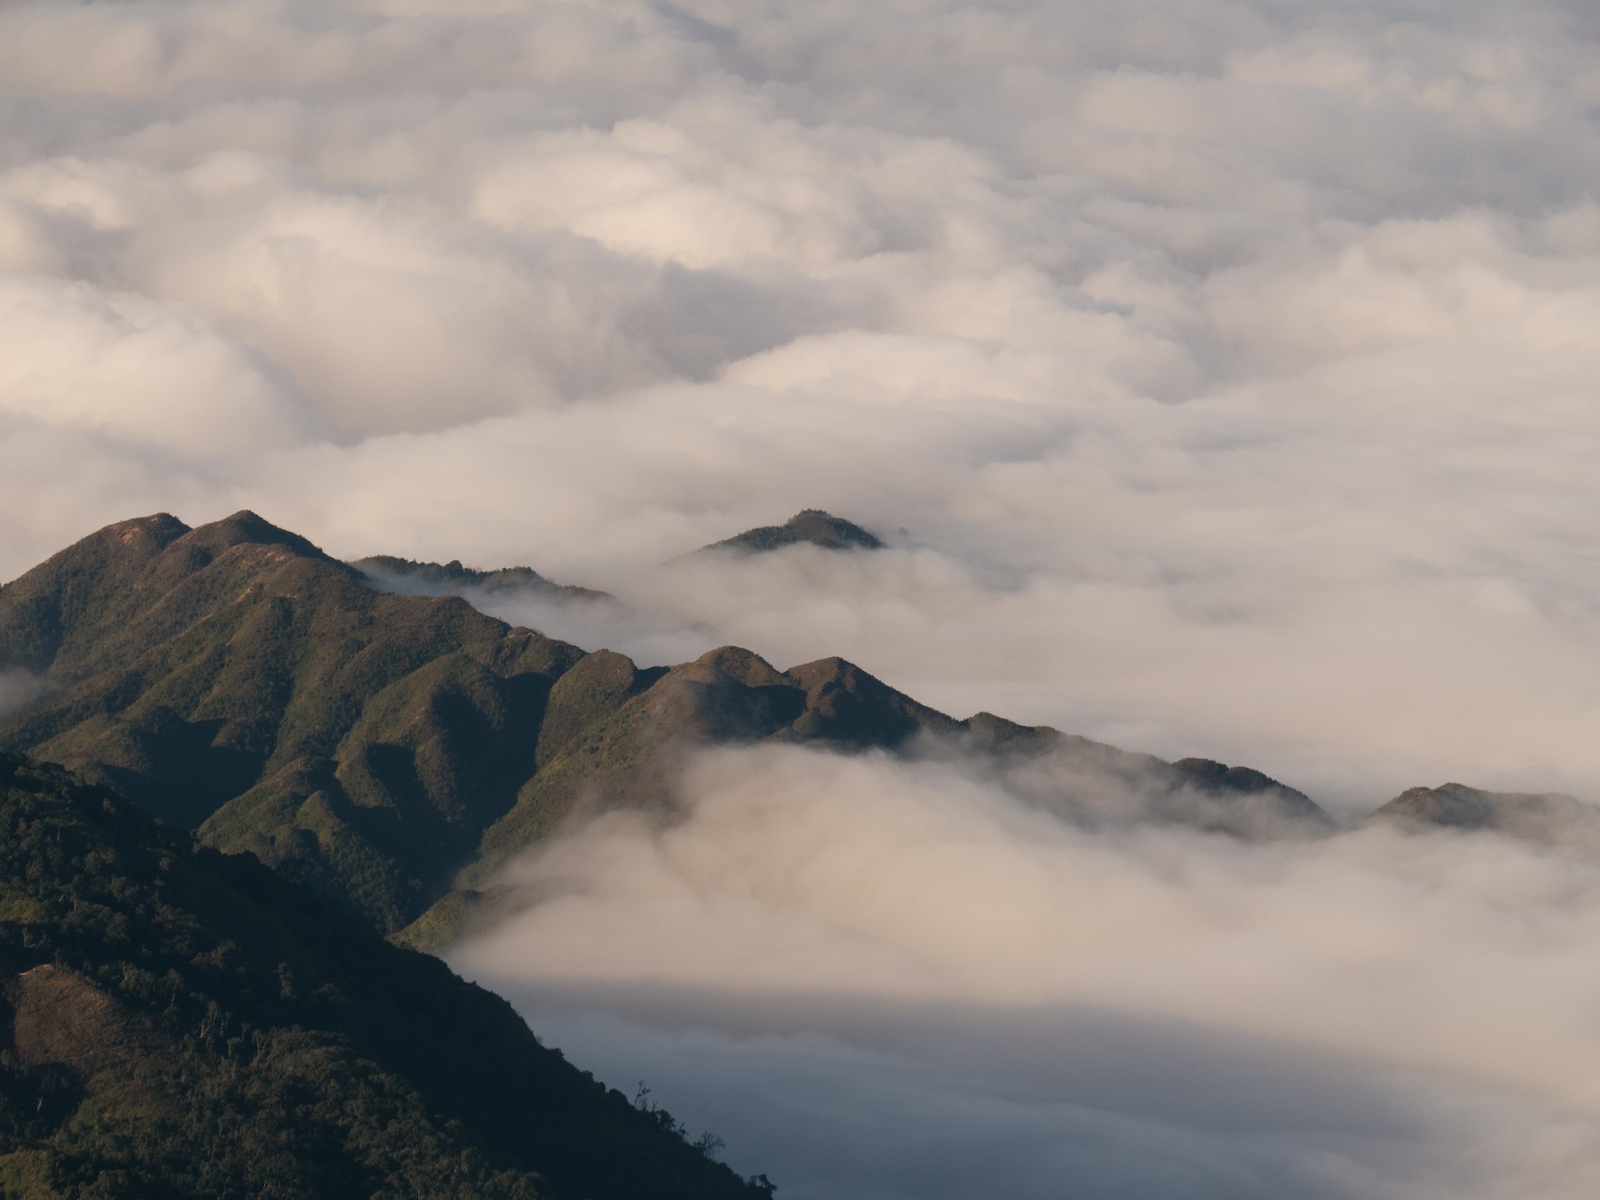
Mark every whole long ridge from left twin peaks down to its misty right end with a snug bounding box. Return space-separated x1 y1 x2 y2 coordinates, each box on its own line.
0 512 1326 931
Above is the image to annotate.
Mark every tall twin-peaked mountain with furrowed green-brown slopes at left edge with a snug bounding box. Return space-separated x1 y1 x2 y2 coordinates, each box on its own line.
0 512 582 928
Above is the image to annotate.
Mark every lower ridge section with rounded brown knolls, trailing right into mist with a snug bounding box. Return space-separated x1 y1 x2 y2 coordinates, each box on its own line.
406 662 1333 950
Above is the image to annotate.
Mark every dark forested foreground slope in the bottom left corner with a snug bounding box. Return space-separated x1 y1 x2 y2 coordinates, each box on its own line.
0 757 771 1200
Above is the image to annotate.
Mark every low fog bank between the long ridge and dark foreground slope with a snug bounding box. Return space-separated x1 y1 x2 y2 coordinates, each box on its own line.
451 747 1600 1200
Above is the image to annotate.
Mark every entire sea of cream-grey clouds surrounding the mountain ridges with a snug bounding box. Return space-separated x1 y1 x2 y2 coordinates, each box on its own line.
0 0 1600 1200
